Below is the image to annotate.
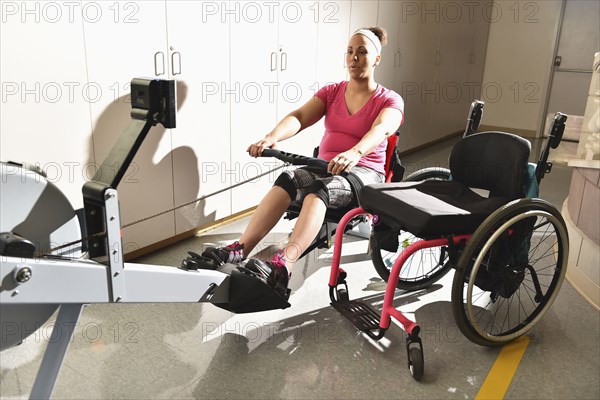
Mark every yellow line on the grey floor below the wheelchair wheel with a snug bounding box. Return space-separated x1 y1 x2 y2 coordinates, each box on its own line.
475 336 530 400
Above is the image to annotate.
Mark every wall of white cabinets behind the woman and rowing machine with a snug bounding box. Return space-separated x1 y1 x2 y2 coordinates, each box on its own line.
0 0 490 253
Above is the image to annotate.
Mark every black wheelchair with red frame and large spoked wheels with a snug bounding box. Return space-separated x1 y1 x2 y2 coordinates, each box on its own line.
264 102 569 380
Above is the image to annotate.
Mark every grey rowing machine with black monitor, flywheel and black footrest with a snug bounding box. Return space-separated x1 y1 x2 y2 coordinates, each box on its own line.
0 79 290 398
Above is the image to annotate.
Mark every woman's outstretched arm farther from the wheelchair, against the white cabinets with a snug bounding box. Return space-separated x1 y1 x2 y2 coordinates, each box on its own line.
246 96 325 157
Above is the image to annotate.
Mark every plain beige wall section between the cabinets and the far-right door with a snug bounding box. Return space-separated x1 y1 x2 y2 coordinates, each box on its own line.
482 0 562 136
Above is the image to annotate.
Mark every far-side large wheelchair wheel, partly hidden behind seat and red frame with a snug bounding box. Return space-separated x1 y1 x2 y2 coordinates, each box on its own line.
369 167 450 291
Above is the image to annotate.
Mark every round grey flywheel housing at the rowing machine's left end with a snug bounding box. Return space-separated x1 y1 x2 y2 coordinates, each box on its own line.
0 162 81 350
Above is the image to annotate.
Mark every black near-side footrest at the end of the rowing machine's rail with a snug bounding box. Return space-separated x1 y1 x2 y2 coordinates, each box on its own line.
210 264 291 314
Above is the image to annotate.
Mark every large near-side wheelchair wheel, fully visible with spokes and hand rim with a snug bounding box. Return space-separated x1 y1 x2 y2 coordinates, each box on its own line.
452 199 569 346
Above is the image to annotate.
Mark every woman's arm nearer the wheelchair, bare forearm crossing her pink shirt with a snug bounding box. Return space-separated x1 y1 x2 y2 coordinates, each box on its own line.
328 108 402 175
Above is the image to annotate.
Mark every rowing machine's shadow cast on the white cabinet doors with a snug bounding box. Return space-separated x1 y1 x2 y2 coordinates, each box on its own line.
86 81 215 253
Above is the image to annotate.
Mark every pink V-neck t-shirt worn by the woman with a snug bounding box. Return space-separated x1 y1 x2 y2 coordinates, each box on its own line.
315 81 404 174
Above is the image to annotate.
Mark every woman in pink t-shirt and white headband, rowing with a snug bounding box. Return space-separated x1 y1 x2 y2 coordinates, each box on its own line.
203 27 404 295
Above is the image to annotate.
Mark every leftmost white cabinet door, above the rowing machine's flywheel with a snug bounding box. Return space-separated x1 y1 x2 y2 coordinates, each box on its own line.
0 1 95 208
